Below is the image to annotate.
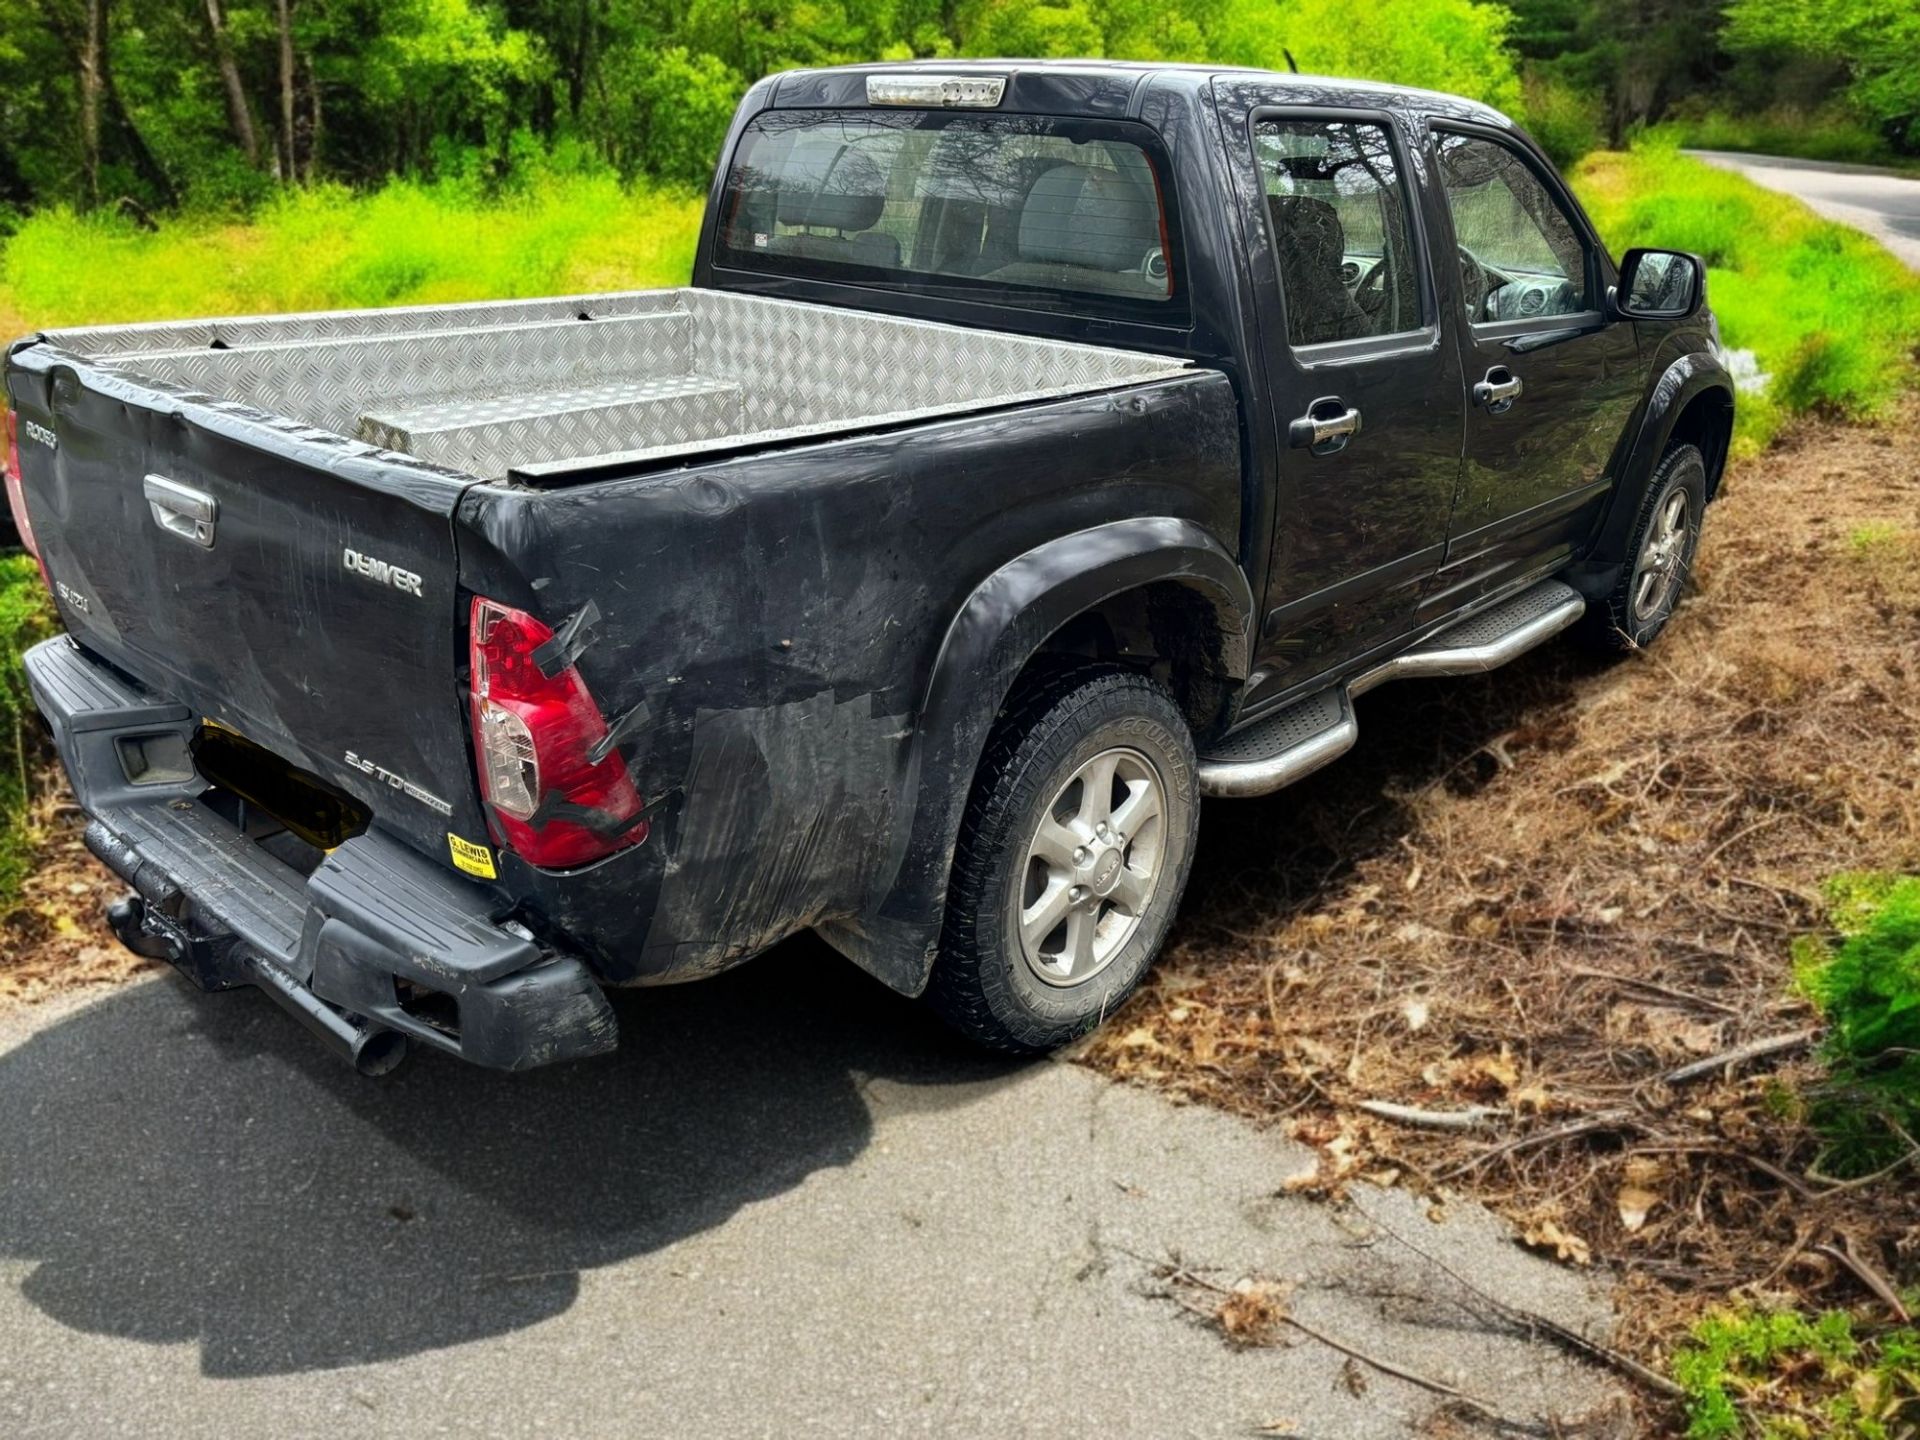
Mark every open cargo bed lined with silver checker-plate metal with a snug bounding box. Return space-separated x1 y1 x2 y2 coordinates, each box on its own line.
44 288 1185 484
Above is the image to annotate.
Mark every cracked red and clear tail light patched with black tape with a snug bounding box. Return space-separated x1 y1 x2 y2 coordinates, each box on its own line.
470 595 647 870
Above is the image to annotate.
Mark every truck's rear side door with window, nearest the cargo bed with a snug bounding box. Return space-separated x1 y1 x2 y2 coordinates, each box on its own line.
1219 81 1465 707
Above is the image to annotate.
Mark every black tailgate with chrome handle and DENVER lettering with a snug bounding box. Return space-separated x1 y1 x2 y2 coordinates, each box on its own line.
8 346 488 862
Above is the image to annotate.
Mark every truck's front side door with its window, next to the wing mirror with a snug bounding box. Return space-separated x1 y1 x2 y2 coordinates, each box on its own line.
1425 123 1642 614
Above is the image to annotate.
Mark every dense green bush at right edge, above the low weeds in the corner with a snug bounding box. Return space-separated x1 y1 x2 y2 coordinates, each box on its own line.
1793 874 1920 1175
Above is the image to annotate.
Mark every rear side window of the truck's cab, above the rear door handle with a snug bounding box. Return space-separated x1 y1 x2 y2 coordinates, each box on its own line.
1254 119 1423 346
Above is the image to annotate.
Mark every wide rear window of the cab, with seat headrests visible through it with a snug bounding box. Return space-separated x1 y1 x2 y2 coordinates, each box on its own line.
716 111 1187 324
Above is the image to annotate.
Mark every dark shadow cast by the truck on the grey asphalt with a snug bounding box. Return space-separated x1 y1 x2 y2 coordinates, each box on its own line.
0 939 1018 1377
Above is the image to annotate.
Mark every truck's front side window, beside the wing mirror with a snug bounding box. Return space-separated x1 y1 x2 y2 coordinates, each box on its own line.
1434 131 1594 324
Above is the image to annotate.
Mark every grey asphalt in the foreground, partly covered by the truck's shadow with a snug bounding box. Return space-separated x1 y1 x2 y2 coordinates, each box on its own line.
0 943 1619 1440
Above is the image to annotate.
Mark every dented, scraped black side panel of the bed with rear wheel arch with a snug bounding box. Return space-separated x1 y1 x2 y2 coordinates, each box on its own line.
459 374 1248 993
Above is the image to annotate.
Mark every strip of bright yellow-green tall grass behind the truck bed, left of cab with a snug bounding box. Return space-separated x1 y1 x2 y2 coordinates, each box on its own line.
0 175 701 338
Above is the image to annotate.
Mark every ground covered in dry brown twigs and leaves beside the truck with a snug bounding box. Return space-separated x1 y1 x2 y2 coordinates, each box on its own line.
1083 403 1920 1354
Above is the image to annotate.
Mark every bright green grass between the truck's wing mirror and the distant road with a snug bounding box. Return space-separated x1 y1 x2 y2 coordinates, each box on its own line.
1572 138 1920 451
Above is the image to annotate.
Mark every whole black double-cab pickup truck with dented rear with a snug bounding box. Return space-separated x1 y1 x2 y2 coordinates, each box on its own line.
6 61 1734 1071
